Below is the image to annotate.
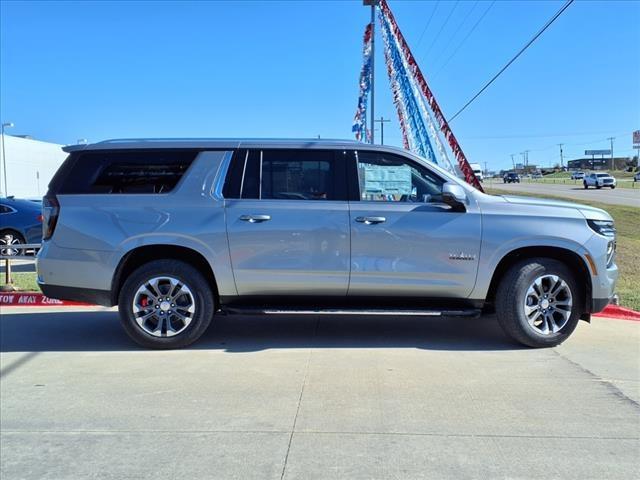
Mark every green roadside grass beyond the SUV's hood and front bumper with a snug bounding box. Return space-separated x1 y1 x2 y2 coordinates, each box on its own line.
487 188 640 310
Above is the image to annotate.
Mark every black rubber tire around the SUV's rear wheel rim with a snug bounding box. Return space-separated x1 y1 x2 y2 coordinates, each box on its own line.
118 259 215 349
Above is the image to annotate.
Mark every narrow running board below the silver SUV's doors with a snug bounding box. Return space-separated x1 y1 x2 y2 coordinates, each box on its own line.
222 307 482 318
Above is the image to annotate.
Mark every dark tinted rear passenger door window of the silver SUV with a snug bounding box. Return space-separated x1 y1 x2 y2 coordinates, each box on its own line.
224 149 347 200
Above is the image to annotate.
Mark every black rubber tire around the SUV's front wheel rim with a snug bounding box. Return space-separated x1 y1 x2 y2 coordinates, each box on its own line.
496 258 584 348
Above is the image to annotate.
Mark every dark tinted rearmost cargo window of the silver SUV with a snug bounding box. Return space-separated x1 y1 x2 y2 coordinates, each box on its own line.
49 149 198 194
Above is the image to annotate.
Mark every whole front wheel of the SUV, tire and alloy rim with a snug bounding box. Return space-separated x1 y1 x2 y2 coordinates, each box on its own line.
496 258 584 347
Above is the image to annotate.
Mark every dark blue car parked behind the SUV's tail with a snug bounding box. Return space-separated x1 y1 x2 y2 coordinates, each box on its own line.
0 197 42 255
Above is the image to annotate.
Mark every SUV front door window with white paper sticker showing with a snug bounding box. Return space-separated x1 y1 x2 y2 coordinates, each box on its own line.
356 152 444 202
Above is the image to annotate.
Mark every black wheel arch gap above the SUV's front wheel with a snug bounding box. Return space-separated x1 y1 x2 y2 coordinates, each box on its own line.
486 246 592 313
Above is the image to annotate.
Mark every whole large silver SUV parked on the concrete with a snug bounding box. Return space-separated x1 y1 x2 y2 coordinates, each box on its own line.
38 139 618 348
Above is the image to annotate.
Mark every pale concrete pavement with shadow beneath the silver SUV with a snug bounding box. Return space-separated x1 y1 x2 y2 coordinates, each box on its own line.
0 307 640 480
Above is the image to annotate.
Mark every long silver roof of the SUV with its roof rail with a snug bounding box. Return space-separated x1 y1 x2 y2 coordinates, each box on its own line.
63 138 379 152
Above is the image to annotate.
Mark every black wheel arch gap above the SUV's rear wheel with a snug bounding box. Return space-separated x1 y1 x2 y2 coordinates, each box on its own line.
111 244 219 305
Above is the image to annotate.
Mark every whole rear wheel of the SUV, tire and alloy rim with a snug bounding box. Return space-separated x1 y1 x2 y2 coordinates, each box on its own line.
118 259 215 349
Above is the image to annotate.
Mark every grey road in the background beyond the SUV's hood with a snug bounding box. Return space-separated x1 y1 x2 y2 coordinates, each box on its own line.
487 182 640 207
